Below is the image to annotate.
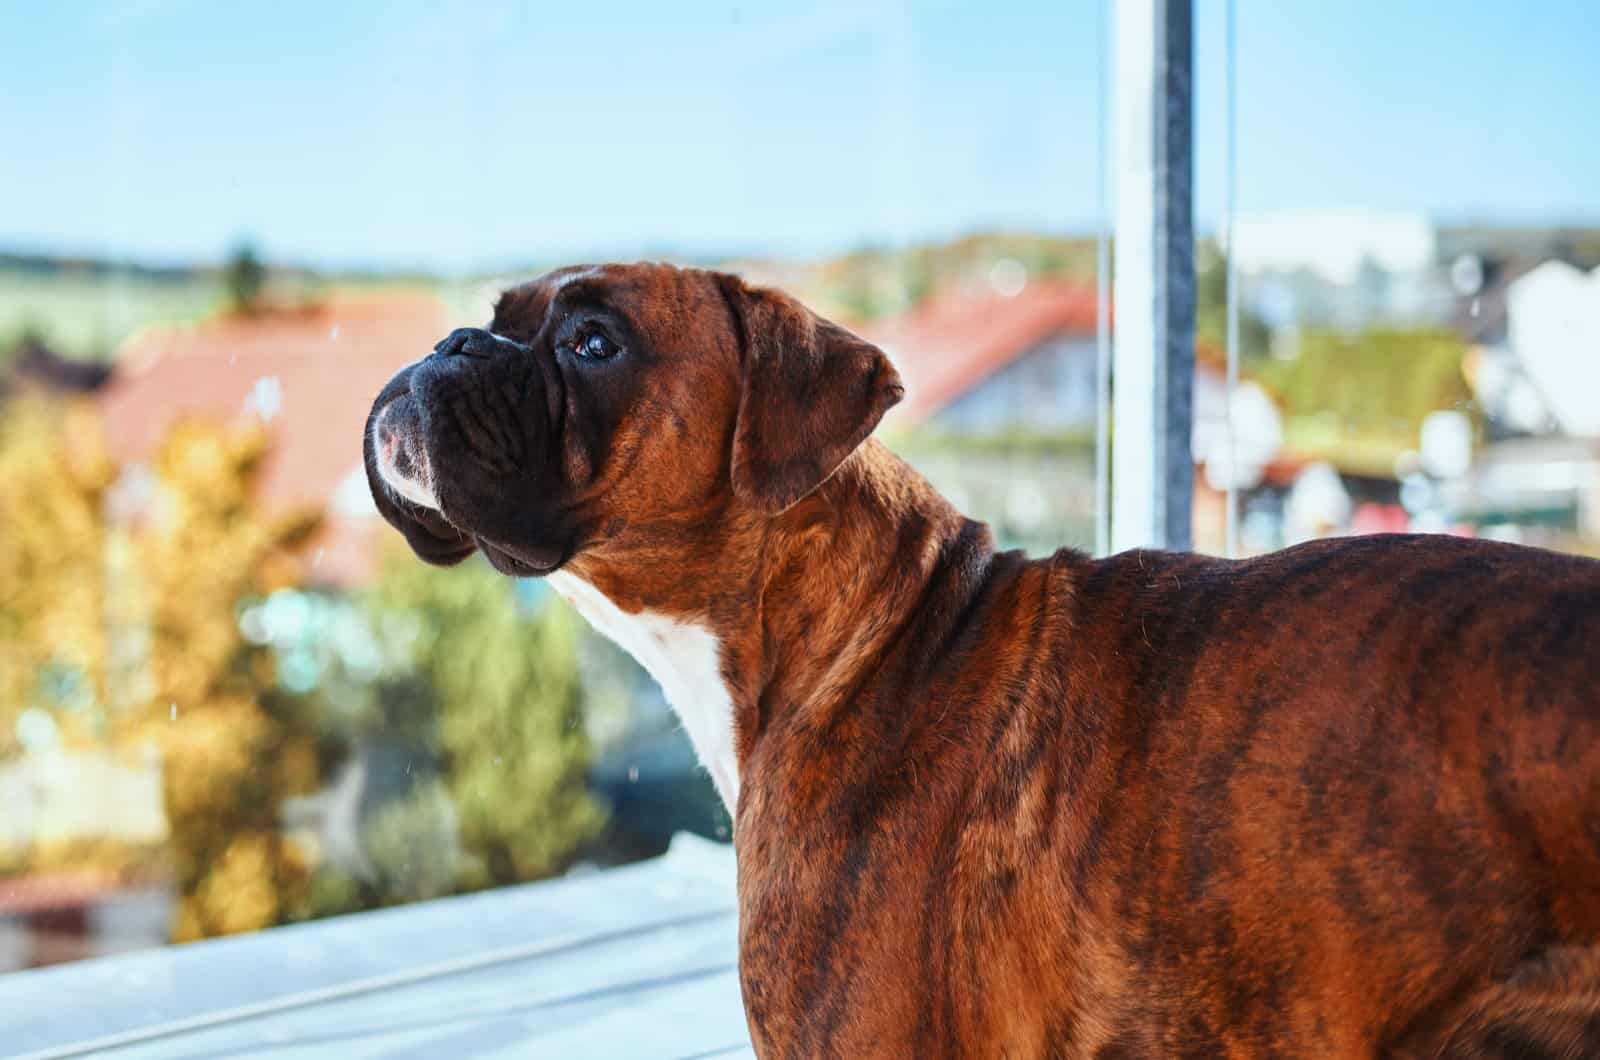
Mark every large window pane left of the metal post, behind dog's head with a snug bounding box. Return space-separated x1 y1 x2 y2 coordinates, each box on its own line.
0 2 1101 970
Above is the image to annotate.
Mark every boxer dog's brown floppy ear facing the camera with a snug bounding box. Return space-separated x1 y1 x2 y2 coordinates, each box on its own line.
717 275 906 514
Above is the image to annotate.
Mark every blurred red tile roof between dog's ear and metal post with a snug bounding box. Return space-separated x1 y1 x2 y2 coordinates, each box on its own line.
859 279 1096 421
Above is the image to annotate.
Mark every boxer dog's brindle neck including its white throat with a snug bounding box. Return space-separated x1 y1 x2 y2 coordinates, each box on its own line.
549 442 987 812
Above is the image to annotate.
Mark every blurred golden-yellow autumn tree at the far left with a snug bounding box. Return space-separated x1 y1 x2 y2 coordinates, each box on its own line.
0 402 320 938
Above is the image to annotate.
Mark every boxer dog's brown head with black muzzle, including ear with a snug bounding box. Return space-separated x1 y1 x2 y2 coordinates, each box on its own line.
365 264 902 575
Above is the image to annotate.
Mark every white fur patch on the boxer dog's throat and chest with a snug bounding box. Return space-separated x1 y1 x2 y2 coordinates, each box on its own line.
546 570 739 813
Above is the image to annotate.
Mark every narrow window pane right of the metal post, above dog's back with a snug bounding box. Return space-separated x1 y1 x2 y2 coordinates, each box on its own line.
1195 0 1600 554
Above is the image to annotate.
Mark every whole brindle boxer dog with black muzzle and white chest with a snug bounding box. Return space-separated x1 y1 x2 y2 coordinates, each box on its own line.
365 264 1600 1058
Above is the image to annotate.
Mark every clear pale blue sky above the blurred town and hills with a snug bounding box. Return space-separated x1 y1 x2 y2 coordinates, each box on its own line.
0 0 1600 271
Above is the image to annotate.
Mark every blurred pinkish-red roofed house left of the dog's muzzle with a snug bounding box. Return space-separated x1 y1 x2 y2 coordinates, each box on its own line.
98 290 450 584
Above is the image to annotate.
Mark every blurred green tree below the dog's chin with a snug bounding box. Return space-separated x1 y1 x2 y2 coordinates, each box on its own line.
356 549 603 889
